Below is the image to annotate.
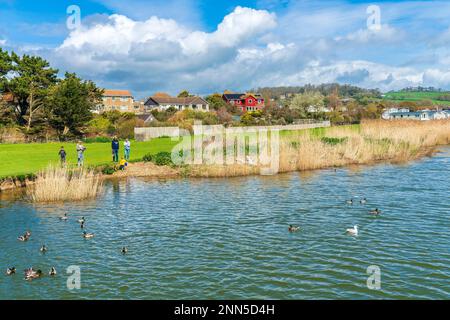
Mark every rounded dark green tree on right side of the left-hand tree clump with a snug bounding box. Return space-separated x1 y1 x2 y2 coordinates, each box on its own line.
47 73 103 138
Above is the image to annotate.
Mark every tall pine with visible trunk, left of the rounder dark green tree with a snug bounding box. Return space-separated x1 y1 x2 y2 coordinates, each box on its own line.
6 52 58 131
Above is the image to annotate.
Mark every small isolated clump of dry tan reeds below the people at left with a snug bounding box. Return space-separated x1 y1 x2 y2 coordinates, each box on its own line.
27 167 103 203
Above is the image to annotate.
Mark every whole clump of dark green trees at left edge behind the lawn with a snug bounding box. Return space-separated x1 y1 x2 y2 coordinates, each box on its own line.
0 48 103 140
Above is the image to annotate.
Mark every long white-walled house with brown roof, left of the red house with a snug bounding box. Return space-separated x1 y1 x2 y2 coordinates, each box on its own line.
144 93 209 112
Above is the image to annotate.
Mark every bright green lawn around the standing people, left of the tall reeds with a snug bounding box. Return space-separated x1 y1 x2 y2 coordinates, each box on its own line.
0 138 176 178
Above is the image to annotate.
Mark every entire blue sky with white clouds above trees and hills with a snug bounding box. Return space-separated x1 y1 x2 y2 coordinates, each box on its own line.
0 0 450 98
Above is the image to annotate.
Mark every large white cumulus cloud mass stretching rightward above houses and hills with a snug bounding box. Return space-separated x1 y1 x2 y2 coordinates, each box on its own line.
37 0 450 97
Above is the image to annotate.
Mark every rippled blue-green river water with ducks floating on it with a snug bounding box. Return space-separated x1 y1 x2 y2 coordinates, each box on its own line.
0 148 450 299
